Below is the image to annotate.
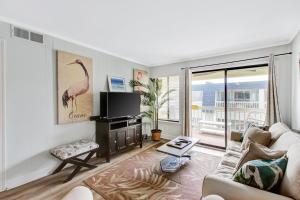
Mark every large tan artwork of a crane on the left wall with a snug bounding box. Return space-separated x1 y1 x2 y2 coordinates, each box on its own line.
56 51 93 124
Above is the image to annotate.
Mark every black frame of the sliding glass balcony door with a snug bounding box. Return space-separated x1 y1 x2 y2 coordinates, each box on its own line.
190 63 268 149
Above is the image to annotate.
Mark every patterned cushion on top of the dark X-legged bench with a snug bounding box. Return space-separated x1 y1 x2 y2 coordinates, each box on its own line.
50 139 99 160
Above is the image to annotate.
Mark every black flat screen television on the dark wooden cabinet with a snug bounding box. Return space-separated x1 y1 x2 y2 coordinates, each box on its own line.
100 92 141 119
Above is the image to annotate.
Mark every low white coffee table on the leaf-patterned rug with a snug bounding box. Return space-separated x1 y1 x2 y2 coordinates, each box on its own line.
156 136 199 172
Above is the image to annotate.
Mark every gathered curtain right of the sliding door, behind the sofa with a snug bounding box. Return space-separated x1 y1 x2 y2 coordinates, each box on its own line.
265 54 281 126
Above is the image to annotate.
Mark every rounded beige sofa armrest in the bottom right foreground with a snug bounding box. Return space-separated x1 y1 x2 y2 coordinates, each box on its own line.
202 175 293 200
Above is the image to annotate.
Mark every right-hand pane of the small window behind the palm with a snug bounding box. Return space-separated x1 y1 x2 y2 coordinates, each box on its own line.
169 76 179 121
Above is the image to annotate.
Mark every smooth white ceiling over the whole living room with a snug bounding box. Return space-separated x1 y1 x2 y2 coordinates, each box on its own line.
0 0 300 66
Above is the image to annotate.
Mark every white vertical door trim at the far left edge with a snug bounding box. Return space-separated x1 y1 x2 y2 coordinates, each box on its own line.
0 38 6 192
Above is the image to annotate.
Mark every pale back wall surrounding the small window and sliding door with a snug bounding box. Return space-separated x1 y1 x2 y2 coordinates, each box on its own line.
150 45 291 138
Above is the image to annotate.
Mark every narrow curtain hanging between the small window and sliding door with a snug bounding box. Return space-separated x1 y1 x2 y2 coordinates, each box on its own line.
182 68 192 136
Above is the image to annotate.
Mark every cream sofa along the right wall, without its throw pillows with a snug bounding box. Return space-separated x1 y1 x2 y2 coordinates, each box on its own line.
202 123 300 200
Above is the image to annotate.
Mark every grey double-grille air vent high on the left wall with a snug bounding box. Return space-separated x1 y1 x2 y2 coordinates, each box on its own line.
11 26 44 44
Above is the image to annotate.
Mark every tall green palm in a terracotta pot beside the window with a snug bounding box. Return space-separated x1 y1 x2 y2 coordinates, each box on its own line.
129 78 175 141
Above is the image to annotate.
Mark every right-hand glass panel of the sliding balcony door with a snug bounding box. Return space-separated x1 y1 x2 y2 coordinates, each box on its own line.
227 67 268 132
